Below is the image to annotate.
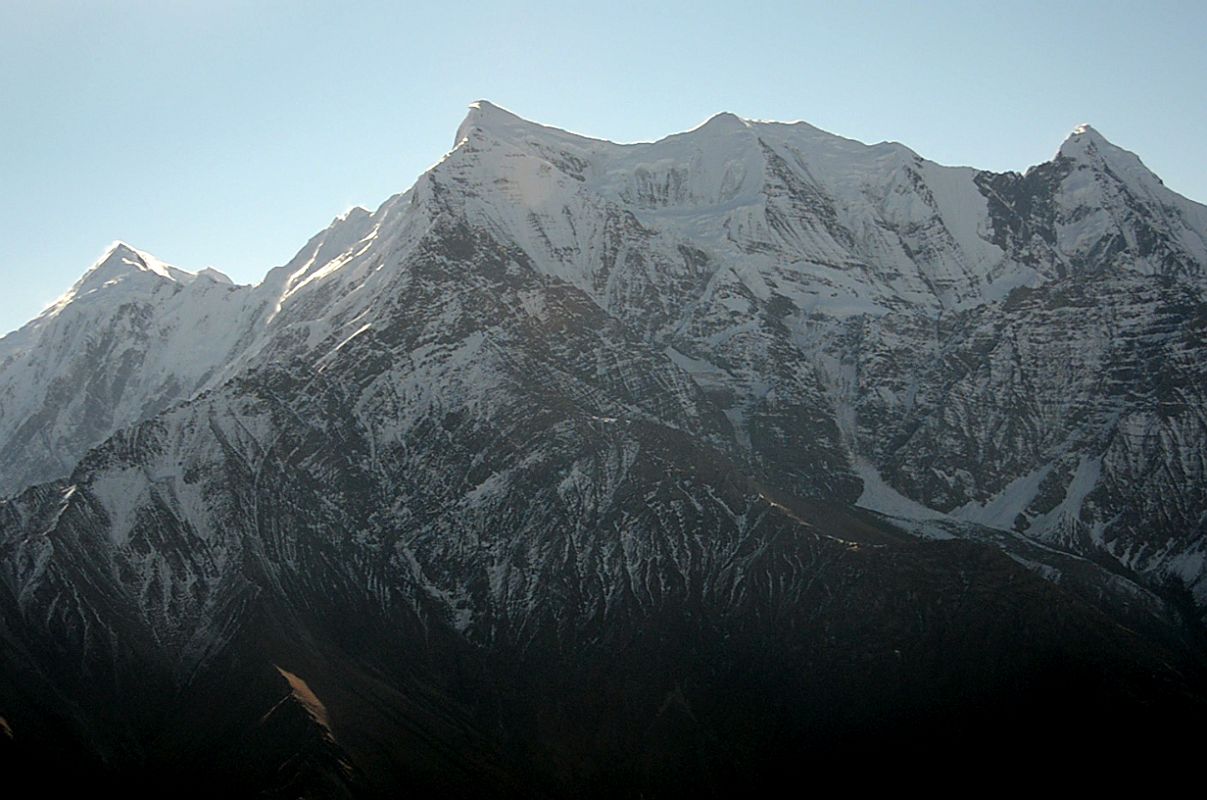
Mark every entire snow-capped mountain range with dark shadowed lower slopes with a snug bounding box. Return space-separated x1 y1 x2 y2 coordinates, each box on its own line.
0 103 1207 796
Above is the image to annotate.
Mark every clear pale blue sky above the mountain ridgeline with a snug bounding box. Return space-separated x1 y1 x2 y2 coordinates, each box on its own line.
0 0 1207 332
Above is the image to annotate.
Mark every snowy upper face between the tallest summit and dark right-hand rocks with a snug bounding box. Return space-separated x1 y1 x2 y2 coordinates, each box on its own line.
441 103 1018 317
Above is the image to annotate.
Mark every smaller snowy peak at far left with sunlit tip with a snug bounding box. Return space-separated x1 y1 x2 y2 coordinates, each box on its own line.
0 243 264 494
